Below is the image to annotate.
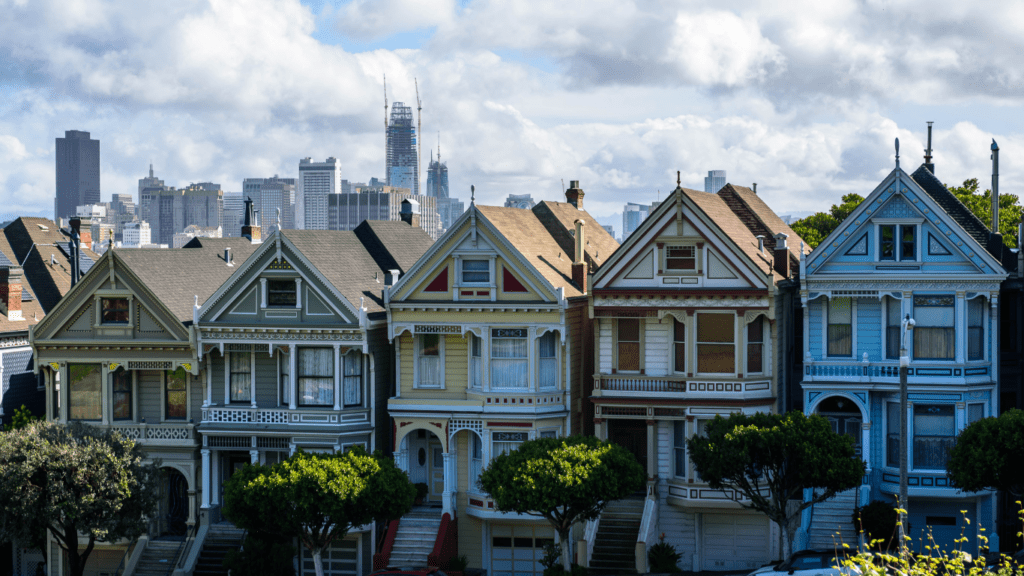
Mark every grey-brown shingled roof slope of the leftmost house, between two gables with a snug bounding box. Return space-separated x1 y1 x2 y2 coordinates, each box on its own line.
115 238 259 325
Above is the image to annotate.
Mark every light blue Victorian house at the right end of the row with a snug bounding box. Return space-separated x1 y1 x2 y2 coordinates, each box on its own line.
797 147 1015 552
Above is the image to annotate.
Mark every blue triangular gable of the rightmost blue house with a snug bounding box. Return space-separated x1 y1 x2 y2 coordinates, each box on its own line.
806 168 1004 275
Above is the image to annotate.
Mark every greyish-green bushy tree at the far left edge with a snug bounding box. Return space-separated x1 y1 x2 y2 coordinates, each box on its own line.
0 416 159 576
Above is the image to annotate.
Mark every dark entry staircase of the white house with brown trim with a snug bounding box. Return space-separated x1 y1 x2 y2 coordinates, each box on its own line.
588 496 644 576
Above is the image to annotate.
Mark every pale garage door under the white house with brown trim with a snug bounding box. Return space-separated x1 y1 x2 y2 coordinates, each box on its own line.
700 513 771 570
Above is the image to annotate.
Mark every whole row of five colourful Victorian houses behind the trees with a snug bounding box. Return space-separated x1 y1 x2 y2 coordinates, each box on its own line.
4 144 1024 576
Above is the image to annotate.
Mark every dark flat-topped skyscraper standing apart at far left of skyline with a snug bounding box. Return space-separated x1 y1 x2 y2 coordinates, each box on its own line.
53 130 99 221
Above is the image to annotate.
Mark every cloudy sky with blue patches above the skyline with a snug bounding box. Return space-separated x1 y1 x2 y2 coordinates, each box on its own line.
0 0 1024 234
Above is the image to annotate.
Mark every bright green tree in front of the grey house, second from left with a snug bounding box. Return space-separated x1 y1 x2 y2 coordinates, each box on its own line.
223 447 416 576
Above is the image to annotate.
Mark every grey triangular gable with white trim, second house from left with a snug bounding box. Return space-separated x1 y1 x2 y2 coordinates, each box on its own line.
199 233 359 324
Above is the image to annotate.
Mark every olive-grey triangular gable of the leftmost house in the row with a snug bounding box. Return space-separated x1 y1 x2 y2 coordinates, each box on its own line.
33 250 188 342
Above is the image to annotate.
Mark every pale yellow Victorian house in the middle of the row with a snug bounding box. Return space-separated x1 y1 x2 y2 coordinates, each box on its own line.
383 181 617 576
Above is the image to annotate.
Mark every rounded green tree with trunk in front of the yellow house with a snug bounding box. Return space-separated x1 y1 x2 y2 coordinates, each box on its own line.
480 436 646 572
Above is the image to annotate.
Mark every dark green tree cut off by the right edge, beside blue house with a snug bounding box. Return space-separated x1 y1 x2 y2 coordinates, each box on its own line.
946 409 1024 498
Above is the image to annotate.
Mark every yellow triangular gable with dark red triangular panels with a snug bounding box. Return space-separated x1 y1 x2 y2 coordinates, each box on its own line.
388 206 569 302
